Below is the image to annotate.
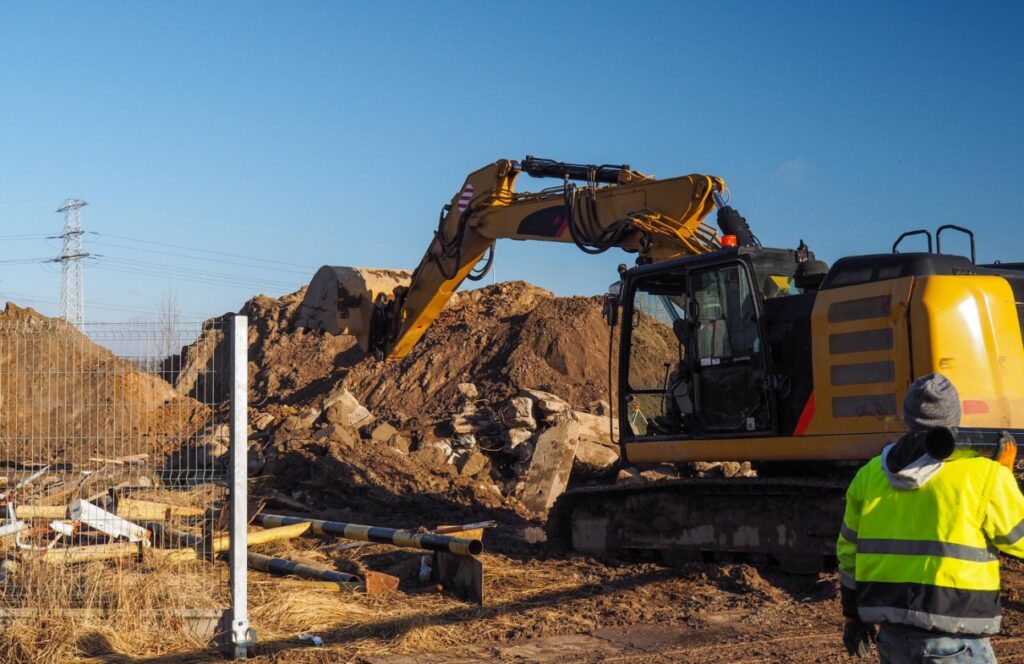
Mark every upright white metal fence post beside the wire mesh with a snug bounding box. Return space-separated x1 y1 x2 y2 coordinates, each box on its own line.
230 316 255 659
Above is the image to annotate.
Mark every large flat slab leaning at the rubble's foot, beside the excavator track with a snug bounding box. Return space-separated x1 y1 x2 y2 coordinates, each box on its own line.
521 414 580 515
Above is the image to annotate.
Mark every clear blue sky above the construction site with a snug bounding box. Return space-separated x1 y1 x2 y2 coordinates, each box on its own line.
0 2 1024 321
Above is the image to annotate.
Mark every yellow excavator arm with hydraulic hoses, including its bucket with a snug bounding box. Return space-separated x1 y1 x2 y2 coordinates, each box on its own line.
298 157 725 359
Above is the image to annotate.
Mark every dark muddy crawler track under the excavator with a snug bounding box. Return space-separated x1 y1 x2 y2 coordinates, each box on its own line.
548 478 849 573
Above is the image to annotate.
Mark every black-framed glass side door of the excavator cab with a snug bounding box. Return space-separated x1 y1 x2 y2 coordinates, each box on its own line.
687 260 773 433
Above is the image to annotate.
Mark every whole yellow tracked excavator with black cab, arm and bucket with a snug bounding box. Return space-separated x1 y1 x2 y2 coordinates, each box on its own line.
298 157 1024 571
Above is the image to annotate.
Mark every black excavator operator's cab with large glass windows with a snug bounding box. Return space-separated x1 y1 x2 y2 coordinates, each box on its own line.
618 247 803 441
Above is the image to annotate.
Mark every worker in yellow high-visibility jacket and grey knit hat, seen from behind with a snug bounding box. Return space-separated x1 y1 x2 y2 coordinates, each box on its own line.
836 374 1024 664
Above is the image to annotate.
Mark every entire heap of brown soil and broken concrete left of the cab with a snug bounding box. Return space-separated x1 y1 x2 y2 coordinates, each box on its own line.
176 282 753 518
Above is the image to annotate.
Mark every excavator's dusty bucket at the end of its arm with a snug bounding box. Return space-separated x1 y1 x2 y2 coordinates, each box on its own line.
295 265 412 350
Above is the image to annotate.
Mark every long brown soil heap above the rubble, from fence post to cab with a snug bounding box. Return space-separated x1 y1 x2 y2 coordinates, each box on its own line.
183 282 608 424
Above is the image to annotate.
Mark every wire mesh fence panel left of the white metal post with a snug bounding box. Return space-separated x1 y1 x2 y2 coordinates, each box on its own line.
0 318 234 613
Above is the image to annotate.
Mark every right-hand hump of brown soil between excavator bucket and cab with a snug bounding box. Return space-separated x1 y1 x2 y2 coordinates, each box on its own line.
344 282 608 421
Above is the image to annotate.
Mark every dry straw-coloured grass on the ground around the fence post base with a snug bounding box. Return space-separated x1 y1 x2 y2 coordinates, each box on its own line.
0 524 622 664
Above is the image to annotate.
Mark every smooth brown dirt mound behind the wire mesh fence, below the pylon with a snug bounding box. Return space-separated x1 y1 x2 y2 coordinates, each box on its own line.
0 302 210 463
